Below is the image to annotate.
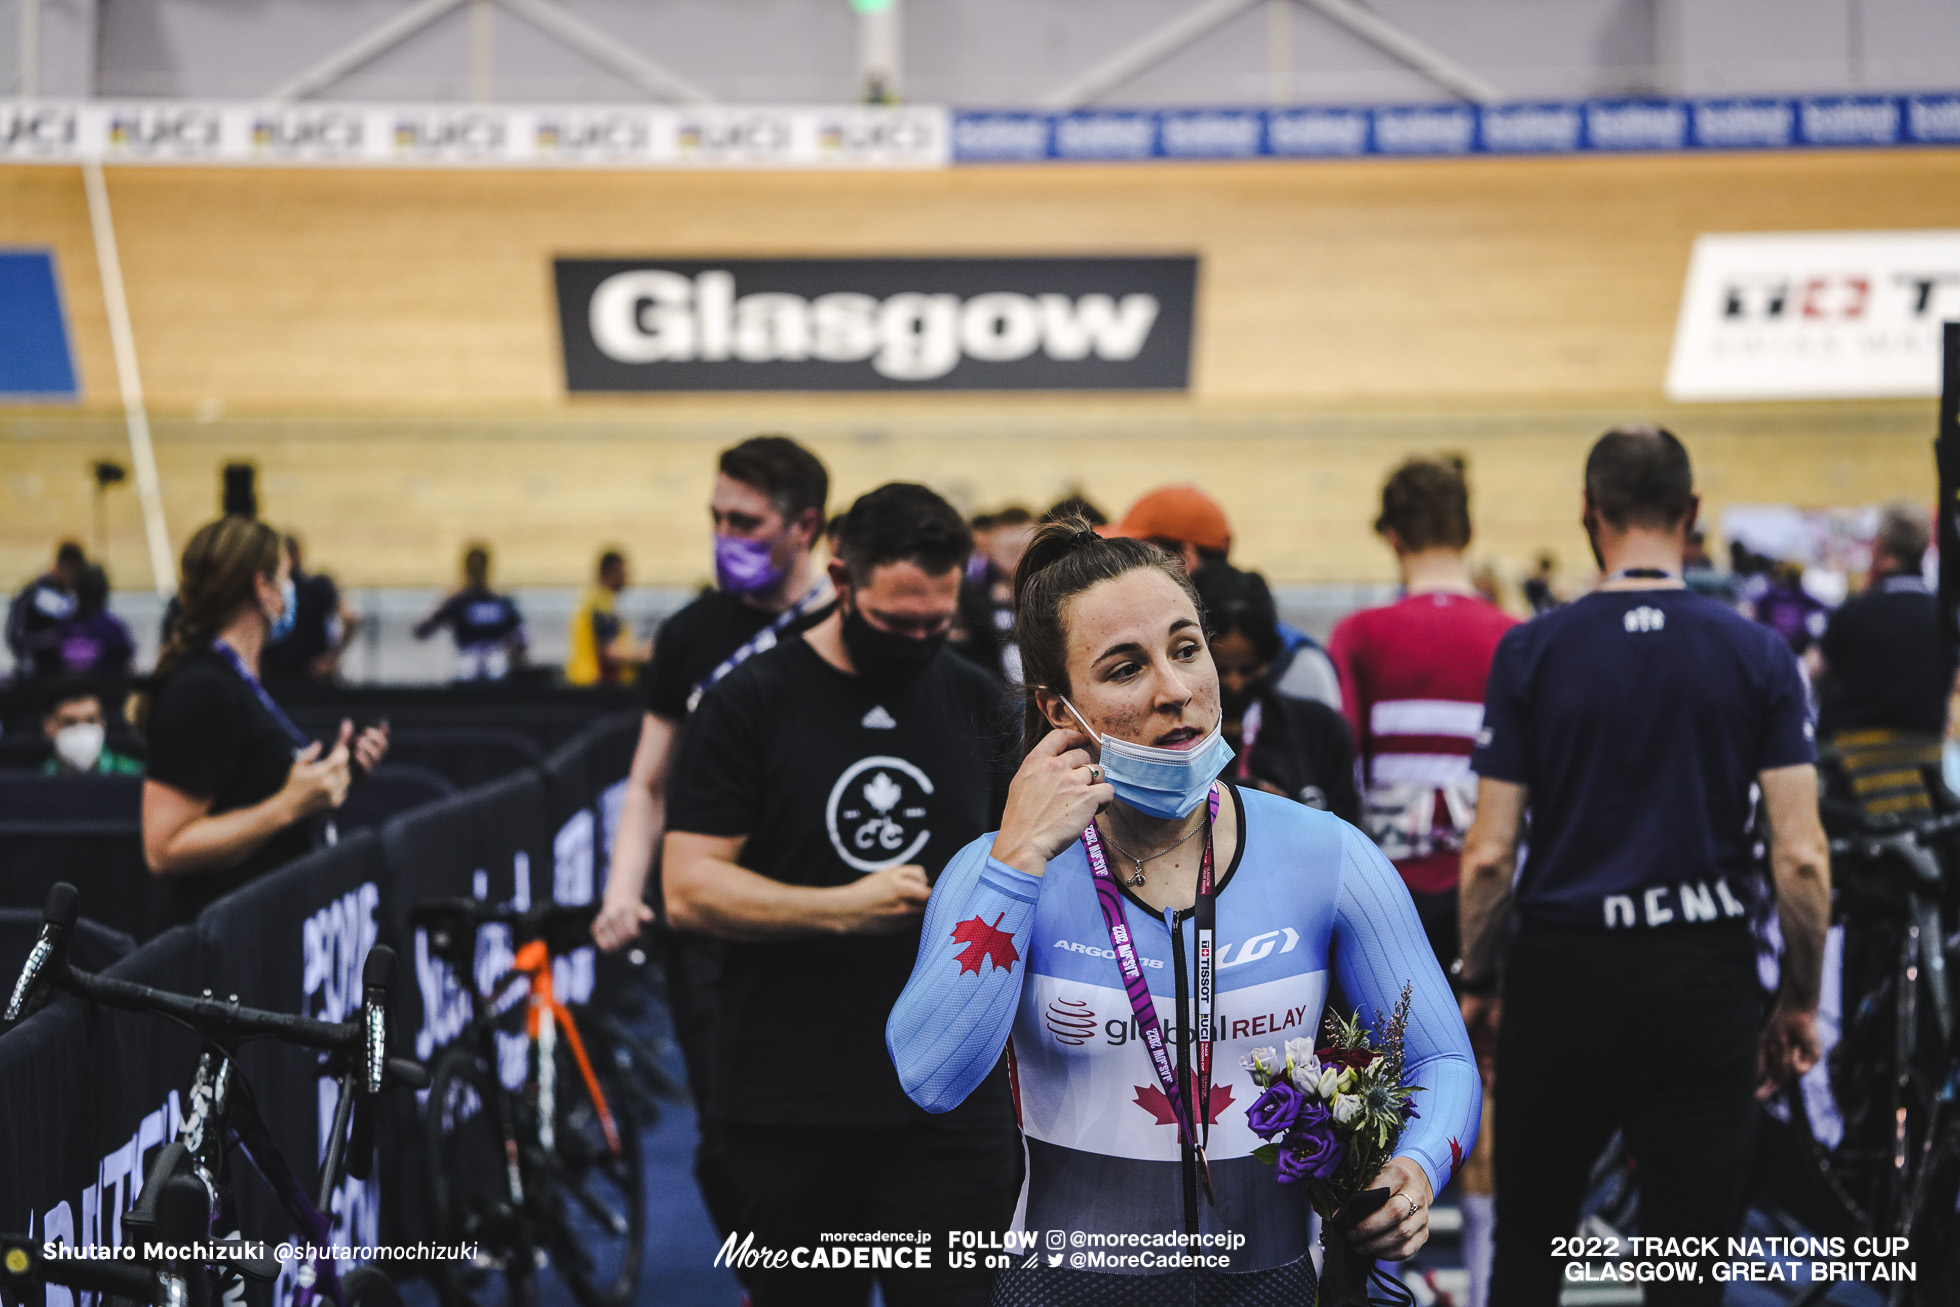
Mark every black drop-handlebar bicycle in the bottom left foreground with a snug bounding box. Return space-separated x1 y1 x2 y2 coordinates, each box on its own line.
6 882 429 1307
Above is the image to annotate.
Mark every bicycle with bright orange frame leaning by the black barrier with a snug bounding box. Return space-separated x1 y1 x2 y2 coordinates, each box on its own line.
410 899 647 1307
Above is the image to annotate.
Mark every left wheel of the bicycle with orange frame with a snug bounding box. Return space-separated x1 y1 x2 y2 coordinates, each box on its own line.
421 1046 537 1307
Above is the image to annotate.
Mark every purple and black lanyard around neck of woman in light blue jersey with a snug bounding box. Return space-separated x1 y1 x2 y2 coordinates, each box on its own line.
1082 786 1219 1207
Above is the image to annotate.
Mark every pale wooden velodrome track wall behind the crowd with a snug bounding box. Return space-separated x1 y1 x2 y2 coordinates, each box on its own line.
0 151 1960 586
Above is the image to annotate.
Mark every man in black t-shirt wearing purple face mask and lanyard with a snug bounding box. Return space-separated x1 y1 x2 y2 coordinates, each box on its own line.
592 435 831 1233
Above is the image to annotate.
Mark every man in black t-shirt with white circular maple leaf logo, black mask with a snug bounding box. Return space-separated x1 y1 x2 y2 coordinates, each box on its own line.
662 484 1021 1307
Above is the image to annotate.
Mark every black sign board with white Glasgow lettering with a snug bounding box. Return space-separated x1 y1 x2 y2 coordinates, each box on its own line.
557 257 1198 392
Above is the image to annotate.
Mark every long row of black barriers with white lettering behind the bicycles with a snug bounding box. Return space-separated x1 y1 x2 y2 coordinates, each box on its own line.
0 713 639 1274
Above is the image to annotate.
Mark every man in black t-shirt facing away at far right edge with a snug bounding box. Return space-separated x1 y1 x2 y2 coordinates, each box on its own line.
1817 504 1954 743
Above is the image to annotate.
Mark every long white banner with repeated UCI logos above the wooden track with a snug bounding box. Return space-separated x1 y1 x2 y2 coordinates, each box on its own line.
0 100 951 169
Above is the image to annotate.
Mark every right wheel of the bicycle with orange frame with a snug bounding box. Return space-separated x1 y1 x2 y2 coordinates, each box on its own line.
543 1023 647 1307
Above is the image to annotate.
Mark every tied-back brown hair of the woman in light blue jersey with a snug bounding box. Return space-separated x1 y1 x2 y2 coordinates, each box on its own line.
1013 515 1203 752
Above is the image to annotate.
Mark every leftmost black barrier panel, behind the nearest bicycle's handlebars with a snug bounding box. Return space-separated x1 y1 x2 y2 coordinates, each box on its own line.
0 924 200 1246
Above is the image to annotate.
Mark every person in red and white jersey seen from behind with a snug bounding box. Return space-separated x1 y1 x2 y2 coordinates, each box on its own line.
1327 459 1517 970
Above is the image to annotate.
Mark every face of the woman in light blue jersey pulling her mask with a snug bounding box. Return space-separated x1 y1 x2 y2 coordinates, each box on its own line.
1041 568 1219 749
